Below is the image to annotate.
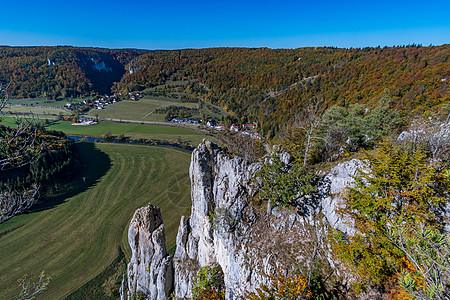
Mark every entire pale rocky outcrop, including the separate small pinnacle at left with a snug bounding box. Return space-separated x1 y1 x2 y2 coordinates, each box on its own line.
120 141 363 299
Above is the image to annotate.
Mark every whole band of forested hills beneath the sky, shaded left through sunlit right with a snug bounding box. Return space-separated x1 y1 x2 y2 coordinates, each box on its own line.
0 45 450 137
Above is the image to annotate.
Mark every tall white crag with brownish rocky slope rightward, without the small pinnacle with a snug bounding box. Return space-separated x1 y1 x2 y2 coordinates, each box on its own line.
174 142 361 299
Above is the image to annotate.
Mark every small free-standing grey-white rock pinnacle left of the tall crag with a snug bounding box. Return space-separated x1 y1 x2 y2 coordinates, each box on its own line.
121 204 173 300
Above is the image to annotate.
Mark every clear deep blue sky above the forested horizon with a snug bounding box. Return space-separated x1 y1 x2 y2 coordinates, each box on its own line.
0 0 450 49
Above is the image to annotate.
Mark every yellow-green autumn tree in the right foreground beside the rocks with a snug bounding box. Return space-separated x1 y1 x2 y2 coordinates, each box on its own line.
334 142 450 299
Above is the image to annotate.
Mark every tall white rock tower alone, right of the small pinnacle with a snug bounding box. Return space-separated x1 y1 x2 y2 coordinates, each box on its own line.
174 142 261 298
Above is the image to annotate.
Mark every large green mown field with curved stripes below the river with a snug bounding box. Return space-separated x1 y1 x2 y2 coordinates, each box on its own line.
0 143 190 299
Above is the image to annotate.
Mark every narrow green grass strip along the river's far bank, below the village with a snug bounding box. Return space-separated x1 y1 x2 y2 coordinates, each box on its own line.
47 122 209 146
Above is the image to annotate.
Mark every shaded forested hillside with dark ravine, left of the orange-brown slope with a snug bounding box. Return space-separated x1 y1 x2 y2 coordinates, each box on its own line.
0 46 144 99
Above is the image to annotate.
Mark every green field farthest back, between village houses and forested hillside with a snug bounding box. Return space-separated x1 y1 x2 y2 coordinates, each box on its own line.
88 96 200 122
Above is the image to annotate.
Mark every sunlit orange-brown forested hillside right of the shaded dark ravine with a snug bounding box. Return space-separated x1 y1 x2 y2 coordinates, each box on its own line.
119 45 450 136
